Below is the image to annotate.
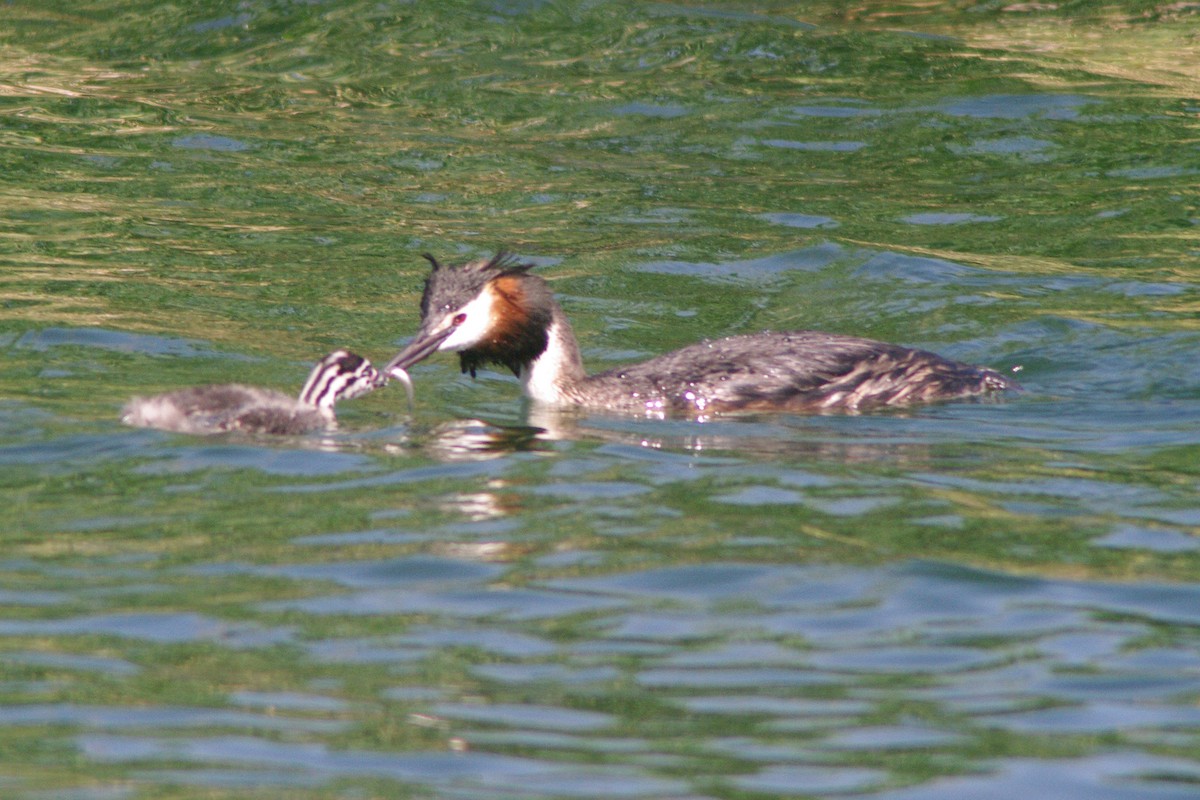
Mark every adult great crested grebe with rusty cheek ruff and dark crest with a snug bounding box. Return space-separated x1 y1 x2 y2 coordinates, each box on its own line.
384 253 1018 416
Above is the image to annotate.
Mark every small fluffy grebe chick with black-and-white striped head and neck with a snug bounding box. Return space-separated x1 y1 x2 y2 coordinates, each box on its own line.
121 350 384 435
